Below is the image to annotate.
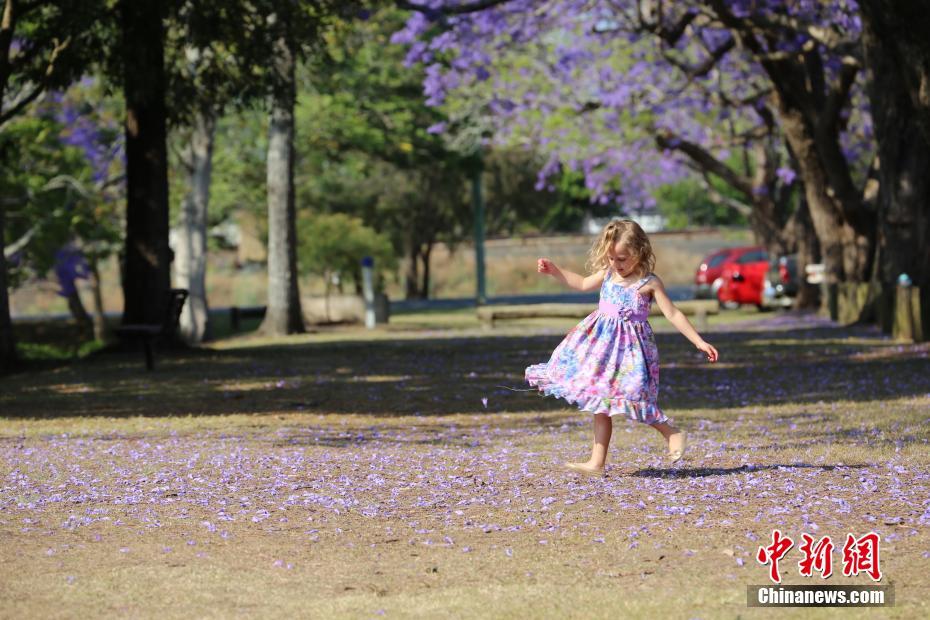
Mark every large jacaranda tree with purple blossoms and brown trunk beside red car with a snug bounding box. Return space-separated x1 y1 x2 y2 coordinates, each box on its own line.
395 0 875 294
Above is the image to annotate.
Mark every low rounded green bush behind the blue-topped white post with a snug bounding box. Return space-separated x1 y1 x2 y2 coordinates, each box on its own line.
297 212 397 287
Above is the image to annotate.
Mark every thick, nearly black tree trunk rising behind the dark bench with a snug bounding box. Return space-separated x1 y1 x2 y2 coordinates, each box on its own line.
119 0 171 324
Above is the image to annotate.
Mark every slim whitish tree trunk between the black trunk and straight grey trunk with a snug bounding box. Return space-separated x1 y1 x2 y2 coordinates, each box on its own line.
174 110 216 344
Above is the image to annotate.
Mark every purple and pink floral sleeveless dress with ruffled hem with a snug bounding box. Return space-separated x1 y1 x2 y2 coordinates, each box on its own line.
526 270 669 424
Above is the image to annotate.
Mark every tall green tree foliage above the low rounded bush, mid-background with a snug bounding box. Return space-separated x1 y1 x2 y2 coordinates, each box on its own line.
296 4 471 288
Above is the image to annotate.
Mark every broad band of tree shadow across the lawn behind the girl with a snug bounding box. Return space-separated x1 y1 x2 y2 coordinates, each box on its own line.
0 320 930 422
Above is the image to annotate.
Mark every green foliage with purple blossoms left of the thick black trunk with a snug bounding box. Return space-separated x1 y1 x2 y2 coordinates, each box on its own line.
0 80 122 286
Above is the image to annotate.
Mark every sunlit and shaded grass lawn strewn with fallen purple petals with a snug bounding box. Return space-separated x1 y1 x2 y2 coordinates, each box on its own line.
0 310 930 618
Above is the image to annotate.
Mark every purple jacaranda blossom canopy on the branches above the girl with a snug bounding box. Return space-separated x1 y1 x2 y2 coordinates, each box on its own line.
392 0 874 208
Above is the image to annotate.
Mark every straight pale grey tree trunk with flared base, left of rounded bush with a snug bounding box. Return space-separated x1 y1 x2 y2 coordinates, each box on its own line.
261 37 304 335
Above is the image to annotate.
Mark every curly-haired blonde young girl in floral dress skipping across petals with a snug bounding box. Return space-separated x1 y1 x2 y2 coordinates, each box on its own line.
526 220 717 476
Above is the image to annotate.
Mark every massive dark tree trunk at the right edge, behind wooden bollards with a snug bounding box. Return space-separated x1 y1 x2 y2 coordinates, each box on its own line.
862 0 930 287
